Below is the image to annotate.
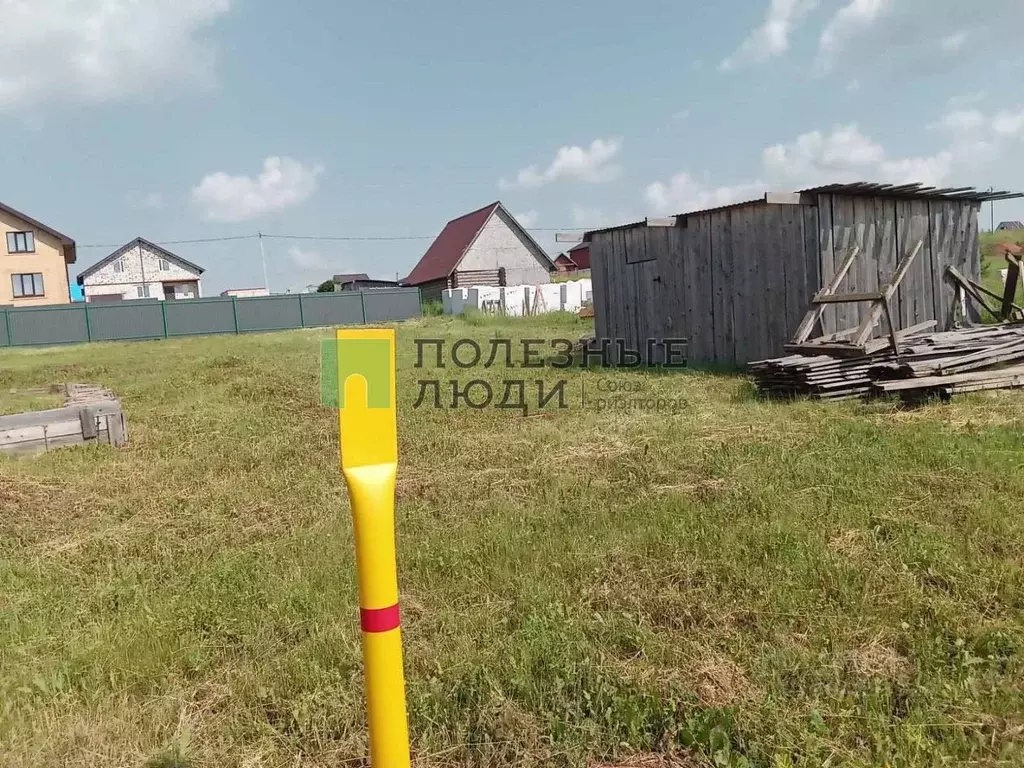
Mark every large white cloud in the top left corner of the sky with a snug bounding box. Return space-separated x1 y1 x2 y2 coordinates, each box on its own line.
0 0 231 111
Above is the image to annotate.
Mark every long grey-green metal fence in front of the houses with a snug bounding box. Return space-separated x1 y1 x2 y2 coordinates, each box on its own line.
0 288 421 347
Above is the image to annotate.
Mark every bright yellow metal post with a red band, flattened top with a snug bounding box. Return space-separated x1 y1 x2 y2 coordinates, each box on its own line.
337 329 410 768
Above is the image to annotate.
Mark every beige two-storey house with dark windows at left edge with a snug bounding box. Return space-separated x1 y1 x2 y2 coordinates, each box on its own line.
0 203 75 306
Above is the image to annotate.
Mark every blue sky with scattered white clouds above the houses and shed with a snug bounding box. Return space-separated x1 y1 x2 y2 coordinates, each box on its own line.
0 0 1024 294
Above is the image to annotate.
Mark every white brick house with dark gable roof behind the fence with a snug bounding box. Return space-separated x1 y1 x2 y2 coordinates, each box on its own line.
78 238 205 301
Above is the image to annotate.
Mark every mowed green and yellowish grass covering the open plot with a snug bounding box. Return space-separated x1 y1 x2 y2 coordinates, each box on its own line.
0 317 1024 768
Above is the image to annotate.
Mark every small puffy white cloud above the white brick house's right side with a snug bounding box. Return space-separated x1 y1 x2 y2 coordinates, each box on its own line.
191 157 324 221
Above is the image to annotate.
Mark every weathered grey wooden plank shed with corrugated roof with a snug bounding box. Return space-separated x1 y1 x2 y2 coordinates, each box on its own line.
584 182 1024 366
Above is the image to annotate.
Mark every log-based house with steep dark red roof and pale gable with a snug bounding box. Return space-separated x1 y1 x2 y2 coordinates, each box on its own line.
401 202 555 301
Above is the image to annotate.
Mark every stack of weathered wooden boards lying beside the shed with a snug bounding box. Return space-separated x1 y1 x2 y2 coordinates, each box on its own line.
748 324 1024 400
